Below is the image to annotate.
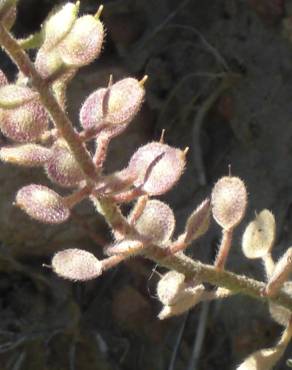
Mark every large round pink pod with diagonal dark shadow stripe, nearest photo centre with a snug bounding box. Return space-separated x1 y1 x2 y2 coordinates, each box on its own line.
128 142 185 195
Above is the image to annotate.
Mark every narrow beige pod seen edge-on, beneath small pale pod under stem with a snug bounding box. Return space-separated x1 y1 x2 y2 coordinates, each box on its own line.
158 285 205 320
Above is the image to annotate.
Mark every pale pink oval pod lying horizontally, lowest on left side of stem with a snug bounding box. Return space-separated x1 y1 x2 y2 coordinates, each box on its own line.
52 248 102 281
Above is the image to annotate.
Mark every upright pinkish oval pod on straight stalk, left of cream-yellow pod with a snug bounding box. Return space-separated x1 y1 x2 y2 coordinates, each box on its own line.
211 176 247 230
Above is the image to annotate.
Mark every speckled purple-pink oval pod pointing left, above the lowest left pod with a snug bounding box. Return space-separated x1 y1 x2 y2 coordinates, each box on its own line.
16 184 70 224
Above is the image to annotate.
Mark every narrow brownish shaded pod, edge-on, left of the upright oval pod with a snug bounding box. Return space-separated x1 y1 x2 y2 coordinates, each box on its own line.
184 199 211 243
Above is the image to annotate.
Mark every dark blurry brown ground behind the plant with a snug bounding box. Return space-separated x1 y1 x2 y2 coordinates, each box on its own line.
0 0 292 370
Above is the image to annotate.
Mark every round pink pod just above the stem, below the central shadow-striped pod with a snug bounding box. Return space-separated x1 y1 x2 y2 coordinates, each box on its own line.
133 200 175 245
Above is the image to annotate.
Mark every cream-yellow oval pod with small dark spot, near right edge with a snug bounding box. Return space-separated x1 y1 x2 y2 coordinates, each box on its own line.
242 209 276 258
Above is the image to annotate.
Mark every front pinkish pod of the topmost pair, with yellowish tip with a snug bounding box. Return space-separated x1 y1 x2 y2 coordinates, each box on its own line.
58 15 104 67
